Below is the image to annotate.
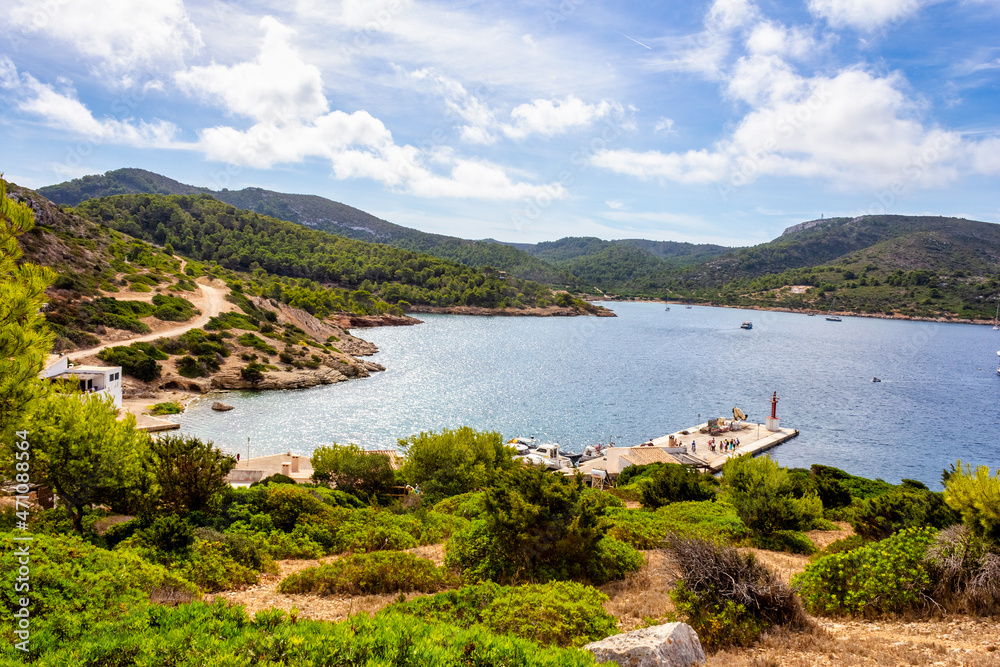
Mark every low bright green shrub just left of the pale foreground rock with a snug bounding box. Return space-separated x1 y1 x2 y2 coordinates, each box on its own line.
381 581 617 646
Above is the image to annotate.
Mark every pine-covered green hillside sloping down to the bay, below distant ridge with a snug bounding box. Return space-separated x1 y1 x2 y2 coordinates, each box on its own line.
76 194 582 308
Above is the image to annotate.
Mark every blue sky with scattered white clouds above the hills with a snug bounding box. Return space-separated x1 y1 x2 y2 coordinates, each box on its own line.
0 0 1000 246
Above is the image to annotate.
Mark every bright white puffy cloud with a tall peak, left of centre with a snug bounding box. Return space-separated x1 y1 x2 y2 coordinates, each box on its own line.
174 17 328 121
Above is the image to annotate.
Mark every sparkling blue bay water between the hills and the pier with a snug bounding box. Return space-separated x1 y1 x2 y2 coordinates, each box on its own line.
172 303 1000 488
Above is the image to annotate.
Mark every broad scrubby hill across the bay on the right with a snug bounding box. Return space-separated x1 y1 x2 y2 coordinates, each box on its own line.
664 215 1000 320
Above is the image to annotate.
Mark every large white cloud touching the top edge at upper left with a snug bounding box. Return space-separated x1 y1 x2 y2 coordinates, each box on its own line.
9 0 202 85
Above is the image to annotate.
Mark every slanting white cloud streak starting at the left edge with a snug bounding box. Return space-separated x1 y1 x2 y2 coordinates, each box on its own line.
0 57 177 147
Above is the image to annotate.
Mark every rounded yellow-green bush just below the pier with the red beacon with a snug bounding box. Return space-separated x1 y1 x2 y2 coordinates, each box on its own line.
722 455 823 536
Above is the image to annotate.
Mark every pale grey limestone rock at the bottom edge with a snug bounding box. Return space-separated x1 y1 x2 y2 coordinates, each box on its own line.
583 623 705 667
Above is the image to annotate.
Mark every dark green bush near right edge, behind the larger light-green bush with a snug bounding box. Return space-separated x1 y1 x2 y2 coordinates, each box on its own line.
849 485 959 540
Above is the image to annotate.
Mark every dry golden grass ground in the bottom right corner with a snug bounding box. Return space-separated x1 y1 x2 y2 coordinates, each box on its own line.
708 617 1000 667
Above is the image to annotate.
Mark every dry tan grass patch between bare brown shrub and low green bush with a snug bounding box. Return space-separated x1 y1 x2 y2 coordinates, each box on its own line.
600 550 674 632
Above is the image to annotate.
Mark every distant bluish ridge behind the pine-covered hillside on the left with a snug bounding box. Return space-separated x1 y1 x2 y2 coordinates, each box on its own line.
38 169 577 285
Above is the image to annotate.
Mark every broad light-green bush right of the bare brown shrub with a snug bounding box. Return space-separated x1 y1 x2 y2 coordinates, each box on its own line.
793 528 937 615
